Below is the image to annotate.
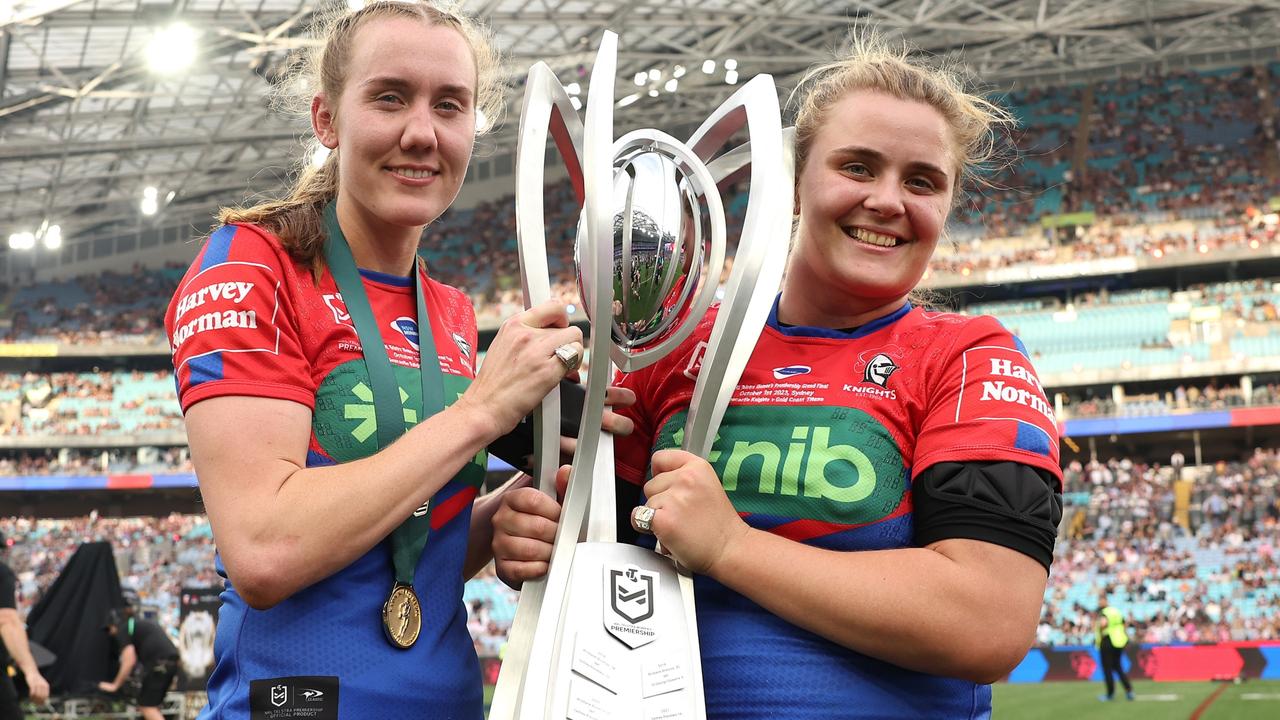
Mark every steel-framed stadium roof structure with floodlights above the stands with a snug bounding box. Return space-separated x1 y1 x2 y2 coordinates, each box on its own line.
0 0 1280 270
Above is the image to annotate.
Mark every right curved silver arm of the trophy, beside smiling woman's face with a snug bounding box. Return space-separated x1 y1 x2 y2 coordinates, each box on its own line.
684 76 795 457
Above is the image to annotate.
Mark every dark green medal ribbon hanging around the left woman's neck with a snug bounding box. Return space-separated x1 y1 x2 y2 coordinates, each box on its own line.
324 202 444 588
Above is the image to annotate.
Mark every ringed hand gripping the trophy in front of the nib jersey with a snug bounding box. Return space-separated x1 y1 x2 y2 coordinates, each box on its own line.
631 450 750 575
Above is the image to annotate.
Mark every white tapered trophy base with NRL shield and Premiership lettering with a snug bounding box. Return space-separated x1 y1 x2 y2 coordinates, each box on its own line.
548 543 703 720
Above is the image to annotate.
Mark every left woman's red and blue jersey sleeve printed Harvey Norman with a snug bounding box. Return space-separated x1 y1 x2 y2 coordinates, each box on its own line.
165 225 316 413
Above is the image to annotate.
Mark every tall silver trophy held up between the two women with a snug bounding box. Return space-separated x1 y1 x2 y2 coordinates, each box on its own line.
489 32 794 720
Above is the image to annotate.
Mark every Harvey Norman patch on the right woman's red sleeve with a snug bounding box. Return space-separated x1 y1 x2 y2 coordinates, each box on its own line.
956 346 1057 438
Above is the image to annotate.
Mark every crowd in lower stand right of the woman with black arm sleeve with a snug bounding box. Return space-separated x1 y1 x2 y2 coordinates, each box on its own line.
1038 450 1280 644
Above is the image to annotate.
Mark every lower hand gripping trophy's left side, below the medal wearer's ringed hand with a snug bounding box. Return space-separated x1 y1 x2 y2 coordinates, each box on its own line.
493 465 570 589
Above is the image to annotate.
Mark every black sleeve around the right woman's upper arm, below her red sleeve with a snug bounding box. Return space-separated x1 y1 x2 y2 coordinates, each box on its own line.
911 462 1062 570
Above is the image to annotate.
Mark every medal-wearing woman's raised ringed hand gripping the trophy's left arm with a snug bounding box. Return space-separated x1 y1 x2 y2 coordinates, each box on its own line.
460 300 584 437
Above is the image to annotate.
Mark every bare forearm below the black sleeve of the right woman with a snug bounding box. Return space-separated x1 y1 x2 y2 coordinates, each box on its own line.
712 530 1046 683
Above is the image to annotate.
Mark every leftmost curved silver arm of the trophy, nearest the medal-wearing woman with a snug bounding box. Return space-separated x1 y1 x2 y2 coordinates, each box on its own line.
489 63 582 720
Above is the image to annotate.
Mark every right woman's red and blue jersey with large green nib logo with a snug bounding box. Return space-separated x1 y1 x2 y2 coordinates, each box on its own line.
616 295 1061 720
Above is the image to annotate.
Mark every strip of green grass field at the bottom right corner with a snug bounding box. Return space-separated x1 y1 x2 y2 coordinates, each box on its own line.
992 680 1280 720
